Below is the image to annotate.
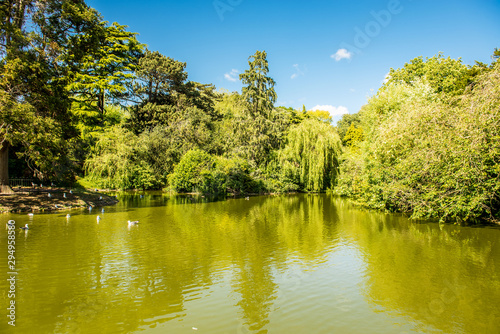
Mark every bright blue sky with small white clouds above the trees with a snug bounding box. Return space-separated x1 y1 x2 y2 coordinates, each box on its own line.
87 0 500 119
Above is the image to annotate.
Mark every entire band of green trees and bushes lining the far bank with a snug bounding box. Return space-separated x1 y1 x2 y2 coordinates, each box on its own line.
0 0 500 222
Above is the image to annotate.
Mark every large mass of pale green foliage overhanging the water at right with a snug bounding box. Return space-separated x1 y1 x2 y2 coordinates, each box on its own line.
336 56 500 222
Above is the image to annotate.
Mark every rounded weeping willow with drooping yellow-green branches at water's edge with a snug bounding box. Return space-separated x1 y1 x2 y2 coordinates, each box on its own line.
279 119 341 191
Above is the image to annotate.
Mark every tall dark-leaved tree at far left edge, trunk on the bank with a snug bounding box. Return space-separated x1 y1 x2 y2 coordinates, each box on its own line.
0 0 100 191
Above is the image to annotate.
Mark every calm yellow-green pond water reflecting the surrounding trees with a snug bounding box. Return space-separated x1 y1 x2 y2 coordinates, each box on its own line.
0 193 500 334
